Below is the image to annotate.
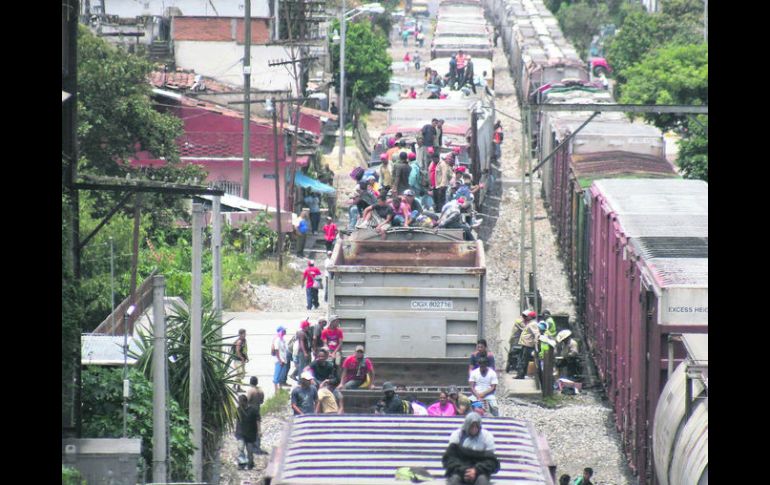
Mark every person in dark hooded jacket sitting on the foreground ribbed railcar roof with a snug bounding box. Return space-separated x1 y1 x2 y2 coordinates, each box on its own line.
441 413 500 485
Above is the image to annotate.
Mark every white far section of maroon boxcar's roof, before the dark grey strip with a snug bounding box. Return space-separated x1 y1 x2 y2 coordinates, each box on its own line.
593 179 708 214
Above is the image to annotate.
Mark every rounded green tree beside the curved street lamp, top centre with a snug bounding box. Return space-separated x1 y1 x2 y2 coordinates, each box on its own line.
331 19 392 106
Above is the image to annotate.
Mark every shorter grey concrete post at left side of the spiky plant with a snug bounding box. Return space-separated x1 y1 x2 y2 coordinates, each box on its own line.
152 275 167 483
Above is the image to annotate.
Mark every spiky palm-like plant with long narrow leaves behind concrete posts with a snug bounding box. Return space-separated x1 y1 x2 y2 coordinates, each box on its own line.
134 304 237 476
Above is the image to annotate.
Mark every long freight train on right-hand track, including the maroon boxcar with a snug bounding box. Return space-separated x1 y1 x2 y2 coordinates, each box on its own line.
484 0 708 484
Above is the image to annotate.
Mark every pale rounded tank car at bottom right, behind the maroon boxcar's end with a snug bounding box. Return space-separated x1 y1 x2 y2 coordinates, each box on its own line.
653 334 708 485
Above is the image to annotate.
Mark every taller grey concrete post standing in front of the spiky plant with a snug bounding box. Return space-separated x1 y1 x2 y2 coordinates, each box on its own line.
190 201 204 482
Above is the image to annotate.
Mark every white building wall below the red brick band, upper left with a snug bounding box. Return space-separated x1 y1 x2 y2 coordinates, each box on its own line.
174 41 296 94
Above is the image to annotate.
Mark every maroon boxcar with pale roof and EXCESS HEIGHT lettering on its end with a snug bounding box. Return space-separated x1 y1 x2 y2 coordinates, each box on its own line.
583 179 708 481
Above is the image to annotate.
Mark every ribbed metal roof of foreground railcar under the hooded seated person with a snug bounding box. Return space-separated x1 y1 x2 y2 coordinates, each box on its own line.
263 414 556 485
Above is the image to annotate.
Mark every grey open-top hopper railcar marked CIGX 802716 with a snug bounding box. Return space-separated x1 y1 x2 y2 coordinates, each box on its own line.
329 228 486 386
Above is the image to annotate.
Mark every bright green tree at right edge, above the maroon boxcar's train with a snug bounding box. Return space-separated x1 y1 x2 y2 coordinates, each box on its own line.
619 44 708 131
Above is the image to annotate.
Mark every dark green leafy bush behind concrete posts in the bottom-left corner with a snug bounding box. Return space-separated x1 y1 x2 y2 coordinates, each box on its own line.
82 366 193 481
